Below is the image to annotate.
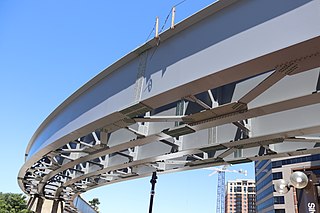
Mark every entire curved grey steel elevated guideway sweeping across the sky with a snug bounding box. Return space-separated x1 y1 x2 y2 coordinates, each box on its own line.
18 0 320 212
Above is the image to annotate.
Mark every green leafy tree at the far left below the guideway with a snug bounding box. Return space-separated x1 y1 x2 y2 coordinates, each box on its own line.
0 192 30 213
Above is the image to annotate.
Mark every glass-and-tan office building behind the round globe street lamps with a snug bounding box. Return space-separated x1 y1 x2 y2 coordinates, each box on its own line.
255 154 320 213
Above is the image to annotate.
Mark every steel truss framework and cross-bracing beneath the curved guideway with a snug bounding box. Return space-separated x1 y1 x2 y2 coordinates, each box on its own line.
22 61 320 209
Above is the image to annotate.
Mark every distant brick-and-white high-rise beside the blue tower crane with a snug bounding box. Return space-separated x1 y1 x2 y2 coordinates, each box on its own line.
225 180 256 213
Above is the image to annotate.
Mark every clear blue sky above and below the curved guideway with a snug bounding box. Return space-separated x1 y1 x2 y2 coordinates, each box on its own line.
0 0 254 213
